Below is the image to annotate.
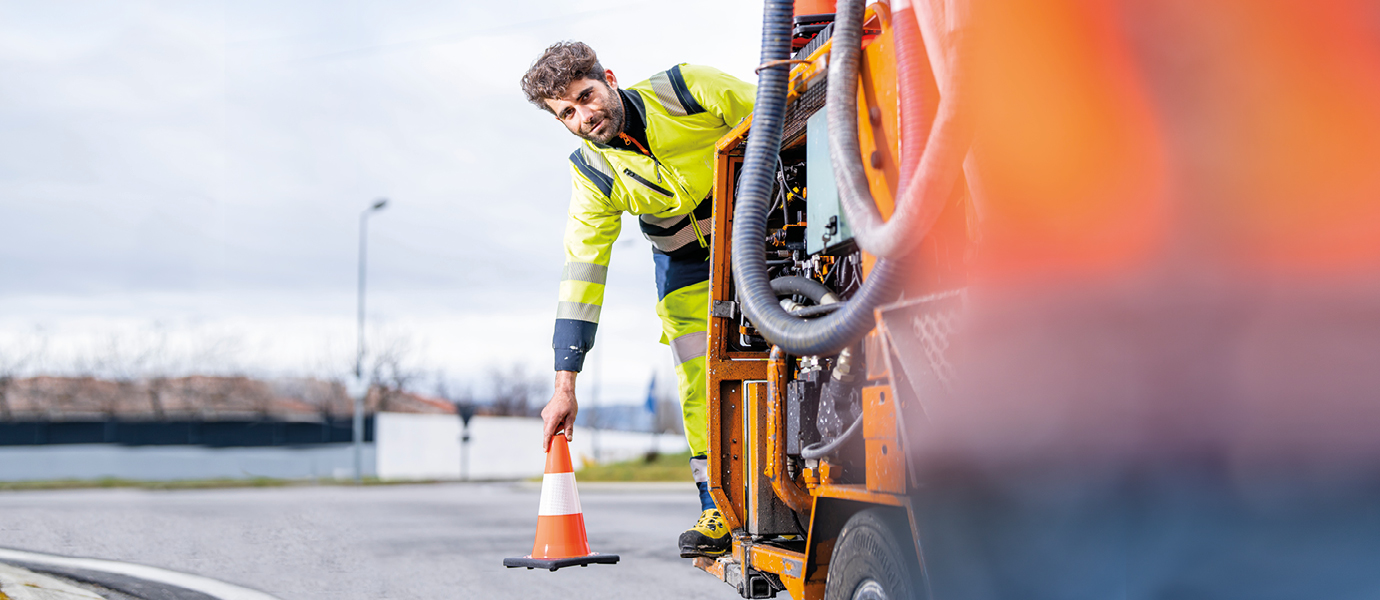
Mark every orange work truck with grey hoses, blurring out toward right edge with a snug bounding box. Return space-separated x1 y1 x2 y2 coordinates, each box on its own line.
696 0 1380 600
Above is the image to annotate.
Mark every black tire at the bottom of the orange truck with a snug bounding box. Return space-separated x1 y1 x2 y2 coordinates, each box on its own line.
824 508 929 600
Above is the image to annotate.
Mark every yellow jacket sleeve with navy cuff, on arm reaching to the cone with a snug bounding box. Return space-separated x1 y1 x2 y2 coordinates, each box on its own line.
551 166 622 371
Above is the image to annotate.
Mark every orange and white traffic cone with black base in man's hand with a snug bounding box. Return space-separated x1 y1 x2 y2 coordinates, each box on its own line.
504 433 618 571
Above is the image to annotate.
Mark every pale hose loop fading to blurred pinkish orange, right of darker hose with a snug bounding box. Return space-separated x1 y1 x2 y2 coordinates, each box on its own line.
825 0 972 258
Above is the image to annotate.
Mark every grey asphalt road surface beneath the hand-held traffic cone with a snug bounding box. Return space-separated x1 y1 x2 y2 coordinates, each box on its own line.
0 483 745 600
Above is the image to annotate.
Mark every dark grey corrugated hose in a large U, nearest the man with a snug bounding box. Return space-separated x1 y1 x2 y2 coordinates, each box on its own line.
733 0 900 356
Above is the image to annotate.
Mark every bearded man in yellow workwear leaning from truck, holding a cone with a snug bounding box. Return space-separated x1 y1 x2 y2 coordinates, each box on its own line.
522 41 756 557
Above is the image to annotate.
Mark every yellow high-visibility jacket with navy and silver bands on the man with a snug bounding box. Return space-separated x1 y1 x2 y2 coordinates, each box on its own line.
552 65 756 371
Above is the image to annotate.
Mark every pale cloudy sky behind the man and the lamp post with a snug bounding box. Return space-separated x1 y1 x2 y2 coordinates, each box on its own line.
0 0 760 403
